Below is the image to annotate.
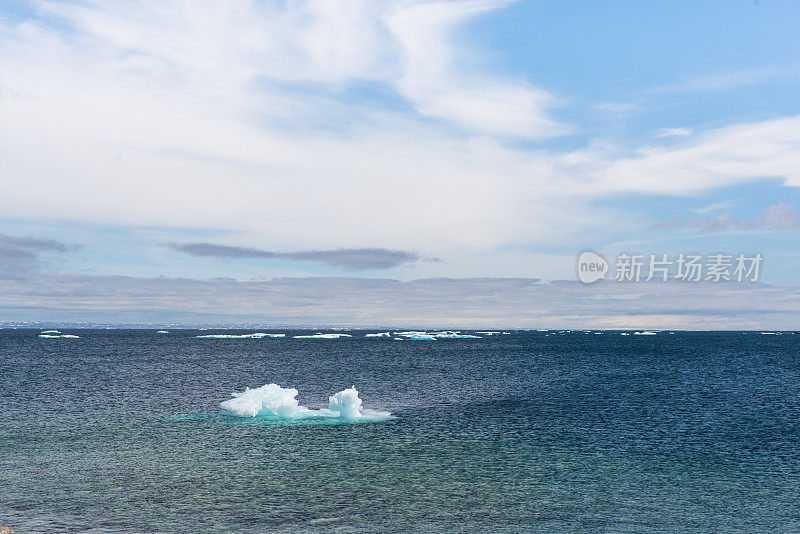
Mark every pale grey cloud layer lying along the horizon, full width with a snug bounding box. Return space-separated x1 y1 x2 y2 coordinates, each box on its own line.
0 273 800 330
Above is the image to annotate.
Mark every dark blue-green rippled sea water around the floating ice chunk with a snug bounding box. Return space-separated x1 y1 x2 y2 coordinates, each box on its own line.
0 330 800 533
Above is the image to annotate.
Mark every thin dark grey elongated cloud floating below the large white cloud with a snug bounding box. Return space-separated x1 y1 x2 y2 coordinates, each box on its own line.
168 243 436 271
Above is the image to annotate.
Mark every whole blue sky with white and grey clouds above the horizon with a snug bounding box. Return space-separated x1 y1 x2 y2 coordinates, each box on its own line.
0 0 800 329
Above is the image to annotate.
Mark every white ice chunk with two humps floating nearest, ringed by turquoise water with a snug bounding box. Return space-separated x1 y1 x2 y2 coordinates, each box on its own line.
220 384 392 422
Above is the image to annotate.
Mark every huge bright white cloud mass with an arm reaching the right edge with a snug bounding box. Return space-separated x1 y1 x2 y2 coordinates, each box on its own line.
0 0 800 284
